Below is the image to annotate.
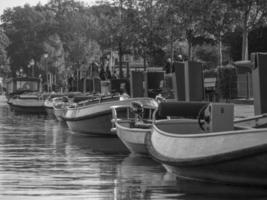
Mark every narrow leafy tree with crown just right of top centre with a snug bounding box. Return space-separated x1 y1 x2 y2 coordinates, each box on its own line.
127 0 166 69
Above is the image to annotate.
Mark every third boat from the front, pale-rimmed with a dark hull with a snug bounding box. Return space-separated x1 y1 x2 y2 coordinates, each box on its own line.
64 95 156 136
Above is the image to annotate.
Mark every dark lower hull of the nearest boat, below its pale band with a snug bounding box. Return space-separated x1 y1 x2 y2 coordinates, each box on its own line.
163 150 267 186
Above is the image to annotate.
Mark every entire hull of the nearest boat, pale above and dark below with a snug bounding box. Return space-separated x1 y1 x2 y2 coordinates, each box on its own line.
146 119 267 186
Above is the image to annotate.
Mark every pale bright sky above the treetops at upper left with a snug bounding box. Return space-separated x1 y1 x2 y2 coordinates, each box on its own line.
0 0 99 15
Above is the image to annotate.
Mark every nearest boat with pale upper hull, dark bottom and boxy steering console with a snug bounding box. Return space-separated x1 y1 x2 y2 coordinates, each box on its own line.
145 102 267 186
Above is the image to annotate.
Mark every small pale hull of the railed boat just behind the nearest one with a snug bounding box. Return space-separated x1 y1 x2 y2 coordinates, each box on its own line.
116 122 151 154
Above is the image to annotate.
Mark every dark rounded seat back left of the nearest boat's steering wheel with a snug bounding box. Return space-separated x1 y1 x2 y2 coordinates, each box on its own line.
157 101 208 119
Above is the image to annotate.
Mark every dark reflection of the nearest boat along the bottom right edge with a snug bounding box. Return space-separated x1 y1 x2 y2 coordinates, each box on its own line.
177 177 267 200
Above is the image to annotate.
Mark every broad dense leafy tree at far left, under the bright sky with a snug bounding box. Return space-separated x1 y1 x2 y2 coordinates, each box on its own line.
1 5 56 74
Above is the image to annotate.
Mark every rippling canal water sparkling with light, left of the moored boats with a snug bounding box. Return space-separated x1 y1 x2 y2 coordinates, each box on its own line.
0 103 266 200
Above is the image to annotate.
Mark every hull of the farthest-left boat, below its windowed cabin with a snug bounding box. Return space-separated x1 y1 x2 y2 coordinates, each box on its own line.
9 93 46 114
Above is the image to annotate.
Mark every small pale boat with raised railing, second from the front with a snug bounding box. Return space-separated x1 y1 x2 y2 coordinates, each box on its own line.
112 99 158 154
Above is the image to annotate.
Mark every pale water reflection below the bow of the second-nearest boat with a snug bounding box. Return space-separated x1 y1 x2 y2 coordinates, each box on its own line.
116 154 177 200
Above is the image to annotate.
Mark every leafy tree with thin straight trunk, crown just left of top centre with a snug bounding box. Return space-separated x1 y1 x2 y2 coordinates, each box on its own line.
92 0 137 77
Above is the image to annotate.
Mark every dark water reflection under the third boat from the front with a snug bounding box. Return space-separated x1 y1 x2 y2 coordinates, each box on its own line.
69 133 129 154
